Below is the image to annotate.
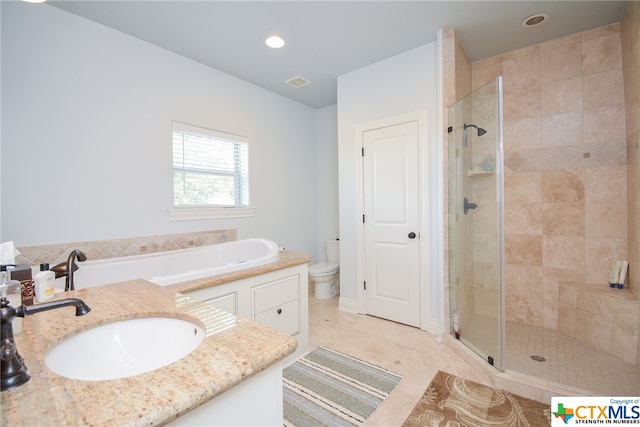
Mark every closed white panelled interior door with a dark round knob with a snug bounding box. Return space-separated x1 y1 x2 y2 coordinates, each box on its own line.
362 121 420 327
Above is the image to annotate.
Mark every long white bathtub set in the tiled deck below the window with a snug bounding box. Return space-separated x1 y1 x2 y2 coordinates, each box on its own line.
69 239 280 291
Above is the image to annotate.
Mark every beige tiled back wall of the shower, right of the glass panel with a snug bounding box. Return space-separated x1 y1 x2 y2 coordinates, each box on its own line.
472 24 627 329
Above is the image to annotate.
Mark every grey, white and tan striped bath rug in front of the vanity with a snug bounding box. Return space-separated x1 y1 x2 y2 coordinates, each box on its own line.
282 347 402 427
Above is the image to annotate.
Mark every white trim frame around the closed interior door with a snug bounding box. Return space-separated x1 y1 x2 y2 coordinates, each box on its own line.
354 110 432 333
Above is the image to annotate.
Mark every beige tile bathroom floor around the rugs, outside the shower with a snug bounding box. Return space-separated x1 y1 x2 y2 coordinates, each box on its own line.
309 294 491 426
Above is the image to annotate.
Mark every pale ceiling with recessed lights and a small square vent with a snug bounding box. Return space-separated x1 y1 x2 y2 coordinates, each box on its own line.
48 0 625 108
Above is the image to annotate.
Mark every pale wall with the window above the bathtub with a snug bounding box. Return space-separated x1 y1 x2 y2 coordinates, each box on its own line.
0 2 320 258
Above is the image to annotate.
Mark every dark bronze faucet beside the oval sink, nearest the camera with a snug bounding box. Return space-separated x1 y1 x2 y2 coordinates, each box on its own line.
0 297 91 391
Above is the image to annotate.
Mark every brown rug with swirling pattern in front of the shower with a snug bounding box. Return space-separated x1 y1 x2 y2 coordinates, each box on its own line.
403 371 551 427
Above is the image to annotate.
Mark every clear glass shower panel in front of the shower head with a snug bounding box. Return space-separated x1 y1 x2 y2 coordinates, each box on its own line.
448 77 504 370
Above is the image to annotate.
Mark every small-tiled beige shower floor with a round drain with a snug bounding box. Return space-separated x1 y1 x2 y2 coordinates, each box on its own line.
505 322 640 396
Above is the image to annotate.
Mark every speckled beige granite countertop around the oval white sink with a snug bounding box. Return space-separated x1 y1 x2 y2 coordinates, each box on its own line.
1 280 298 426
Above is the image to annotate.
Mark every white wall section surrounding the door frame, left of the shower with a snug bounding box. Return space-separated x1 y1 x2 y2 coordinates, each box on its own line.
338 42 442 319
